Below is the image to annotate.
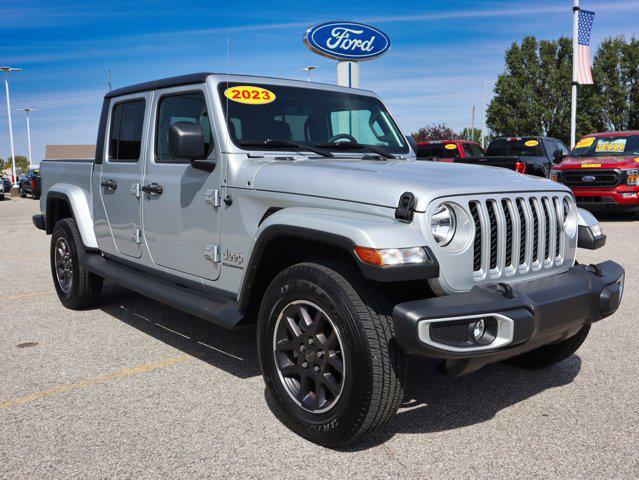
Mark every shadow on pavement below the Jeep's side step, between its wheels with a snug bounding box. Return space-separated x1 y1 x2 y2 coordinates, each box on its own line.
100 283 261 378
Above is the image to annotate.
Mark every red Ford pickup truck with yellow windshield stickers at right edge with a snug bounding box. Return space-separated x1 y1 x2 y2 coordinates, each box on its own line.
550 130 639 212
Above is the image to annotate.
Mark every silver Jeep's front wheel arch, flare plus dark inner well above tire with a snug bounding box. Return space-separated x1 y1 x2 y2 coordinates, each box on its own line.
239 208 439 310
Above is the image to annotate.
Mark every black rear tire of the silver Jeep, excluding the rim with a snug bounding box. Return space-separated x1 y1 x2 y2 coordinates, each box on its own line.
50 218 102 310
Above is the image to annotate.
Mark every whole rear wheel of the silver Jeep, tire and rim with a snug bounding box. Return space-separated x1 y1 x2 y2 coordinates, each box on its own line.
51 218 102 310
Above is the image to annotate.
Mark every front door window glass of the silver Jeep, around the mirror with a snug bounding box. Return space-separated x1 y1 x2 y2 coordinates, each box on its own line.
155 92 213 163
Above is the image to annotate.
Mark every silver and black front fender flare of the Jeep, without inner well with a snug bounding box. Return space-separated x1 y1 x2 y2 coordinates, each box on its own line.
239 207 439 303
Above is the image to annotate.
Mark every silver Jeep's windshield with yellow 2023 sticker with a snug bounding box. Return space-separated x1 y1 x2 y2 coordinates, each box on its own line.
219 82 409 154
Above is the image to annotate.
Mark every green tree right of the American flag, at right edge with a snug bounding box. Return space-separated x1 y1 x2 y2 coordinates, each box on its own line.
579 36 639 133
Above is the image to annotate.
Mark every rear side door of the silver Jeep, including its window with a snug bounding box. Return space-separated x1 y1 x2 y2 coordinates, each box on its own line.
99 94 150 258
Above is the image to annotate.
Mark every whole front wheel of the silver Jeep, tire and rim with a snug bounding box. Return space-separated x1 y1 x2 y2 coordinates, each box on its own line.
258 263 405 447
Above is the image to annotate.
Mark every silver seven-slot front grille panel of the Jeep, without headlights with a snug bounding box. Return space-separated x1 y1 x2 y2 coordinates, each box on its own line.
418 191 577 295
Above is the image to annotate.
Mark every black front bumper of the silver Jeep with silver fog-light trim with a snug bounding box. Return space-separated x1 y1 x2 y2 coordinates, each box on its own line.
393 261 625 375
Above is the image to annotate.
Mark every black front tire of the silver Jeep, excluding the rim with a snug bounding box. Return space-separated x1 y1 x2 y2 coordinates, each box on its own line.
257 261 406 448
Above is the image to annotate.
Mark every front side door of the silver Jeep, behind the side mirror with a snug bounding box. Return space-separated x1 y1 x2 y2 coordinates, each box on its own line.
142 86 222 280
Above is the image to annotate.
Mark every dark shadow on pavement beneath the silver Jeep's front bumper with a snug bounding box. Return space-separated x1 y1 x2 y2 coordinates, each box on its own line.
349 355 581 451
